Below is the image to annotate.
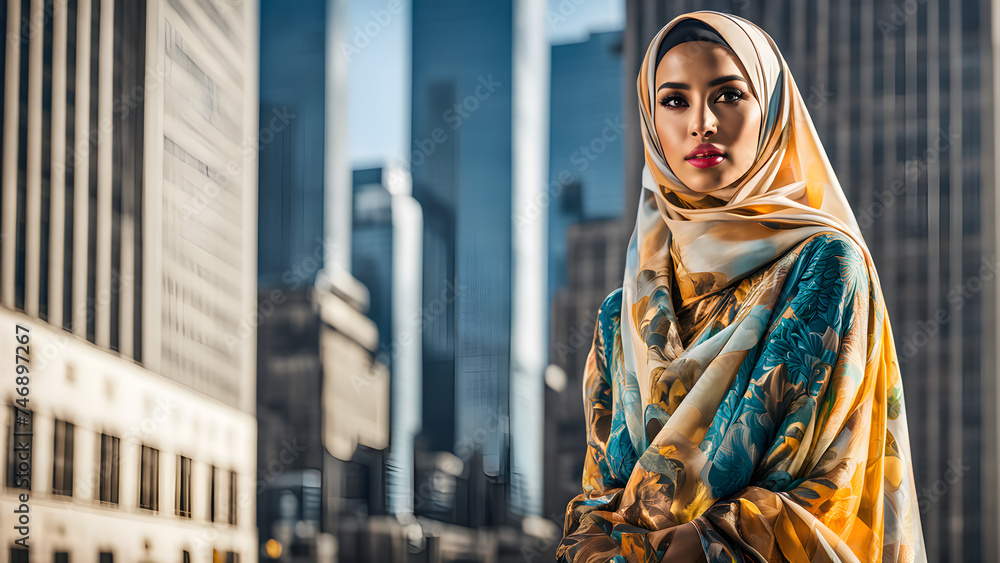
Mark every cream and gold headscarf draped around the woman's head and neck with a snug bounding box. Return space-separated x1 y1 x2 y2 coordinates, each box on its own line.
622 11 877 410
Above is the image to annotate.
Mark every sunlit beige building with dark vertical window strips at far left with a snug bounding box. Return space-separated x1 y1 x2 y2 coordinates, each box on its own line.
0 0 257 563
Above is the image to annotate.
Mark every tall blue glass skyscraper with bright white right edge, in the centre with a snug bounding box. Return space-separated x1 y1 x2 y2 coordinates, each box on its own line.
410 0 548 514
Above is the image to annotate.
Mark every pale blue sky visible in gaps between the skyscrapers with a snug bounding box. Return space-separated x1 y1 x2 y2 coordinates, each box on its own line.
348 0 625 172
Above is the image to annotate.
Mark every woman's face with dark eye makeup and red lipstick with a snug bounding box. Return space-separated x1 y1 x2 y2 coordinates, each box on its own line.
653 41 761 201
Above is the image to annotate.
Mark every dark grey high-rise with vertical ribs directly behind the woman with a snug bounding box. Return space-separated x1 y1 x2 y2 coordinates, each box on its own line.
625 0 1000 561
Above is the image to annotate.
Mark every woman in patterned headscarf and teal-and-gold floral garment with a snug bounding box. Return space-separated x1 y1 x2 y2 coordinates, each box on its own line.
558 11 926 562
